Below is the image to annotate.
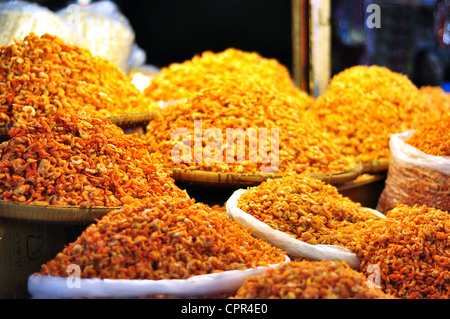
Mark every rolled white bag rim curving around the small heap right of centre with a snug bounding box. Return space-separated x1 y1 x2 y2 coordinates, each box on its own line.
226 189 376 269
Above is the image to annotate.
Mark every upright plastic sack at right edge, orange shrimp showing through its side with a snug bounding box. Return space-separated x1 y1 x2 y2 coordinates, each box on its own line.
377 131 450 213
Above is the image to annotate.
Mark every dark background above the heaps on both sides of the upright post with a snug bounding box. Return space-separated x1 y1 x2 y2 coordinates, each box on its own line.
19 0 450 86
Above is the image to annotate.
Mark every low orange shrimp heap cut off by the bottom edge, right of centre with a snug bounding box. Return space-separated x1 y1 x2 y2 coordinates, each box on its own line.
232 261 393 299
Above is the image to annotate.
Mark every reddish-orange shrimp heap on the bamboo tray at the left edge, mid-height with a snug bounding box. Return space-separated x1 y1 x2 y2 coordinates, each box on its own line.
0 112 187 207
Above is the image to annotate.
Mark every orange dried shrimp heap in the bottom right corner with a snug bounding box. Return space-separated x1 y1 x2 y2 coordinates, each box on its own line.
336 205 450 299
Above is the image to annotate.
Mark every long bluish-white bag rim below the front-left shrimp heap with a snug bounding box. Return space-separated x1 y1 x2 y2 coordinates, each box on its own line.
28 257 289 299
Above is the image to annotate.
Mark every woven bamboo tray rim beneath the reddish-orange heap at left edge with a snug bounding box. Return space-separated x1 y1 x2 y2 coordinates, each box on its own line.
0 200 120 225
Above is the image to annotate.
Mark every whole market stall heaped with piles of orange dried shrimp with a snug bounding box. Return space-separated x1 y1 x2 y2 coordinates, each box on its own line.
0 1 450 300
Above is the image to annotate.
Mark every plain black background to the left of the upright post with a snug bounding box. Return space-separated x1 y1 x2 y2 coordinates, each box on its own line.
29 0 292 68
